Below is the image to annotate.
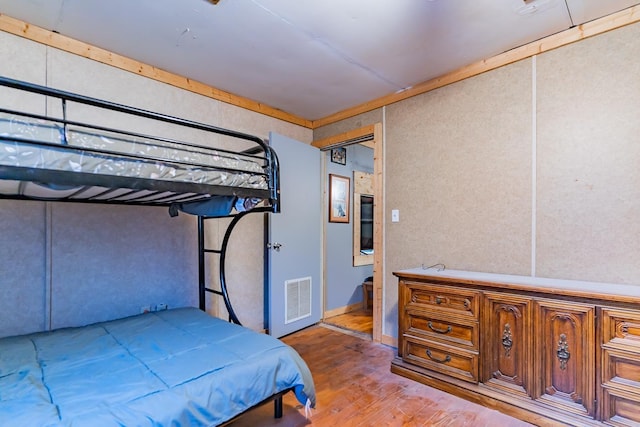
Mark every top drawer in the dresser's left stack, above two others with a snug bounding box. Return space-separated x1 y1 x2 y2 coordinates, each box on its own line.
405 282 480 320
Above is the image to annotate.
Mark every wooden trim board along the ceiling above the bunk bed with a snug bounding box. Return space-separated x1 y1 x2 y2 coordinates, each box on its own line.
0 13 312 128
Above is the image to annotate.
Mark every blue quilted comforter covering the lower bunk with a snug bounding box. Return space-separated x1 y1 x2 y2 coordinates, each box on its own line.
0 308 315 427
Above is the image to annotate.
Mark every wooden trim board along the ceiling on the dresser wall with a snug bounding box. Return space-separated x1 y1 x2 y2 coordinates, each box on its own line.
312 5 640 129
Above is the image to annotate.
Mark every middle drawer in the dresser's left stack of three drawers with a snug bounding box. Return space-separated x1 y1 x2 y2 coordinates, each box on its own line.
403 310 478 350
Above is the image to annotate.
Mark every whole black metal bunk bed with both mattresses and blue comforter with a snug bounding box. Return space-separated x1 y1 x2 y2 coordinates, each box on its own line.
0 77 315 425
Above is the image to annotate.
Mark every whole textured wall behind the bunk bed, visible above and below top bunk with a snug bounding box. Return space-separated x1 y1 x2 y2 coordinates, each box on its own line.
0 32 312 335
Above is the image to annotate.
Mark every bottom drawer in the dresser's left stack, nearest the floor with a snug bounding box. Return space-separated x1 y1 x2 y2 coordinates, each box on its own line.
403 336 478 383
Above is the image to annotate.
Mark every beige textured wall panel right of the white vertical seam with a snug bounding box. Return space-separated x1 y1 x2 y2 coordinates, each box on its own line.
537 25 640 283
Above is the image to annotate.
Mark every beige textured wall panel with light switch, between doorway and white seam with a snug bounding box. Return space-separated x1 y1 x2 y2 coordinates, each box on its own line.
385 60 532 334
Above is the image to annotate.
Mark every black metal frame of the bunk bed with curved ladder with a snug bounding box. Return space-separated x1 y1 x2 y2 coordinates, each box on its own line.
0 76 288 418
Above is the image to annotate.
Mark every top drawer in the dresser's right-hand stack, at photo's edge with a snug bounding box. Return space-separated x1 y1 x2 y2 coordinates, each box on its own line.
602 308 640 352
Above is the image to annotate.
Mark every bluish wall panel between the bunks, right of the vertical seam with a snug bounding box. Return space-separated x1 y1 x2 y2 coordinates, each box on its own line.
51 203 198 328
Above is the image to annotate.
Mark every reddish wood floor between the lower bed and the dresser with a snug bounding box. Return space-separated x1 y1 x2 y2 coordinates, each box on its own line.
231 326 529 427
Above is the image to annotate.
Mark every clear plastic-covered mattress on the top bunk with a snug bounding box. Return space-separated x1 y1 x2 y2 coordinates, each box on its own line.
0 112 268 189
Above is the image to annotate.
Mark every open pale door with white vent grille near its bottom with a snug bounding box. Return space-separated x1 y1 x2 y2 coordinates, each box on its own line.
265 133 322 337
